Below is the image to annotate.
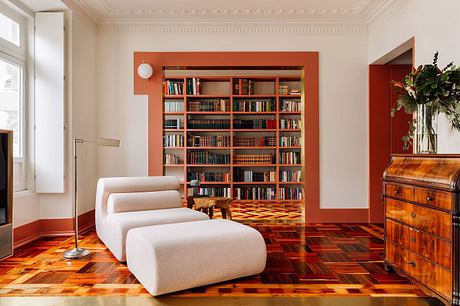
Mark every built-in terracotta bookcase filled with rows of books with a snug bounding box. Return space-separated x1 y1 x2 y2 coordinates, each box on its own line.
163 76 303 201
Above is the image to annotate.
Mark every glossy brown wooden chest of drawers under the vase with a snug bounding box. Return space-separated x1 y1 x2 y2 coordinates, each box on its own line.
383 155 460 305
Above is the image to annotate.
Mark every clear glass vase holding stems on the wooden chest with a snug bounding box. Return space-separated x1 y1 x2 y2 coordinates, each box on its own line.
415 104 438 154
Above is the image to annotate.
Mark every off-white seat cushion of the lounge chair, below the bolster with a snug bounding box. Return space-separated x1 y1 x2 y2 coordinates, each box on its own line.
104 208 209 261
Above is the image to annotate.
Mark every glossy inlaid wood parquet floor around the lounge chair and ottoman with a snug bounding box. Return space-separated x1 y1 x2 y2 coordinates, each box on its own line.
0 223 425 297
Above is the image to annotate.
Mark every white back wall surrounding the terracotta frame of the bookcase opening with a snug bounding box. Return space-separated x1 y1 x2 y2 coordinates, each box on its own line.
96 26 368 208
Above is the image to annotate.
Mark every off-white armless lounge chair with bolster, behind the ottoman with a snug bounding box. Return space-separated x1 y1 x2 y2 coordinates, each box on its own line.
96 176 209 261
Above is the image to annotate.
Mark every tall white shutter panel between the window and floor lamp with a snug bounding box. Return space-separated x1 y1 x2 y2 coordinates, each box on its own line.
35 12 65 193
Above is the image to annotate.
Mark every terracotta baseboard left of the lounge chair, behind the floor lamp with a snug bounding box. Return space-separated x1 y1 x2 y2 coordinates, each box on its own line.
13 209 95 249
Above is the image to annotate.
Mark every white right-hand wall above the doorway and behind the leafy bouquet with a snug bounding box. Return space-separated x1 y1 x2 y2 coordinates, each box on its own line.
369 0 460 153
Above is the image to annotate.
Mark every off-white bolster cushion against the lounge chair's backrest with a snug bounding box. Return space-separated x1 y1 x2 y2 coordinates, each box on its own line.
107 190 182 215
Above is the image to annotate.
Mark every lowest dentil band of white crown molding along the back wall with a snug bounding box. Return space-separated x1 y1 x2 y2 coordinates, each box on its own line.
97 22 367 34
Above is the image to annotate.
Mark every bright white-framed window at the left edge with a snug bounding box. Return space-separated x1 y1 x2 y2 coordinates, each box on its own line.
0 2 27 191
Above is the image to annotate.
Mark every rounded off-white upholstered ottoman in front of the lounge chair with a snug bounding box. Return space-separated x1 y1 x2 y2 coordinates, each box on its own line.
126 220 267 296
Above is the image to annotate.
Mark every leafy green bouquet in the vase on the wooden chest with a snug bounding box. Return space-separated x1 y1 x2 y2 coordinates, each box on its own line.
391 52 460 150
